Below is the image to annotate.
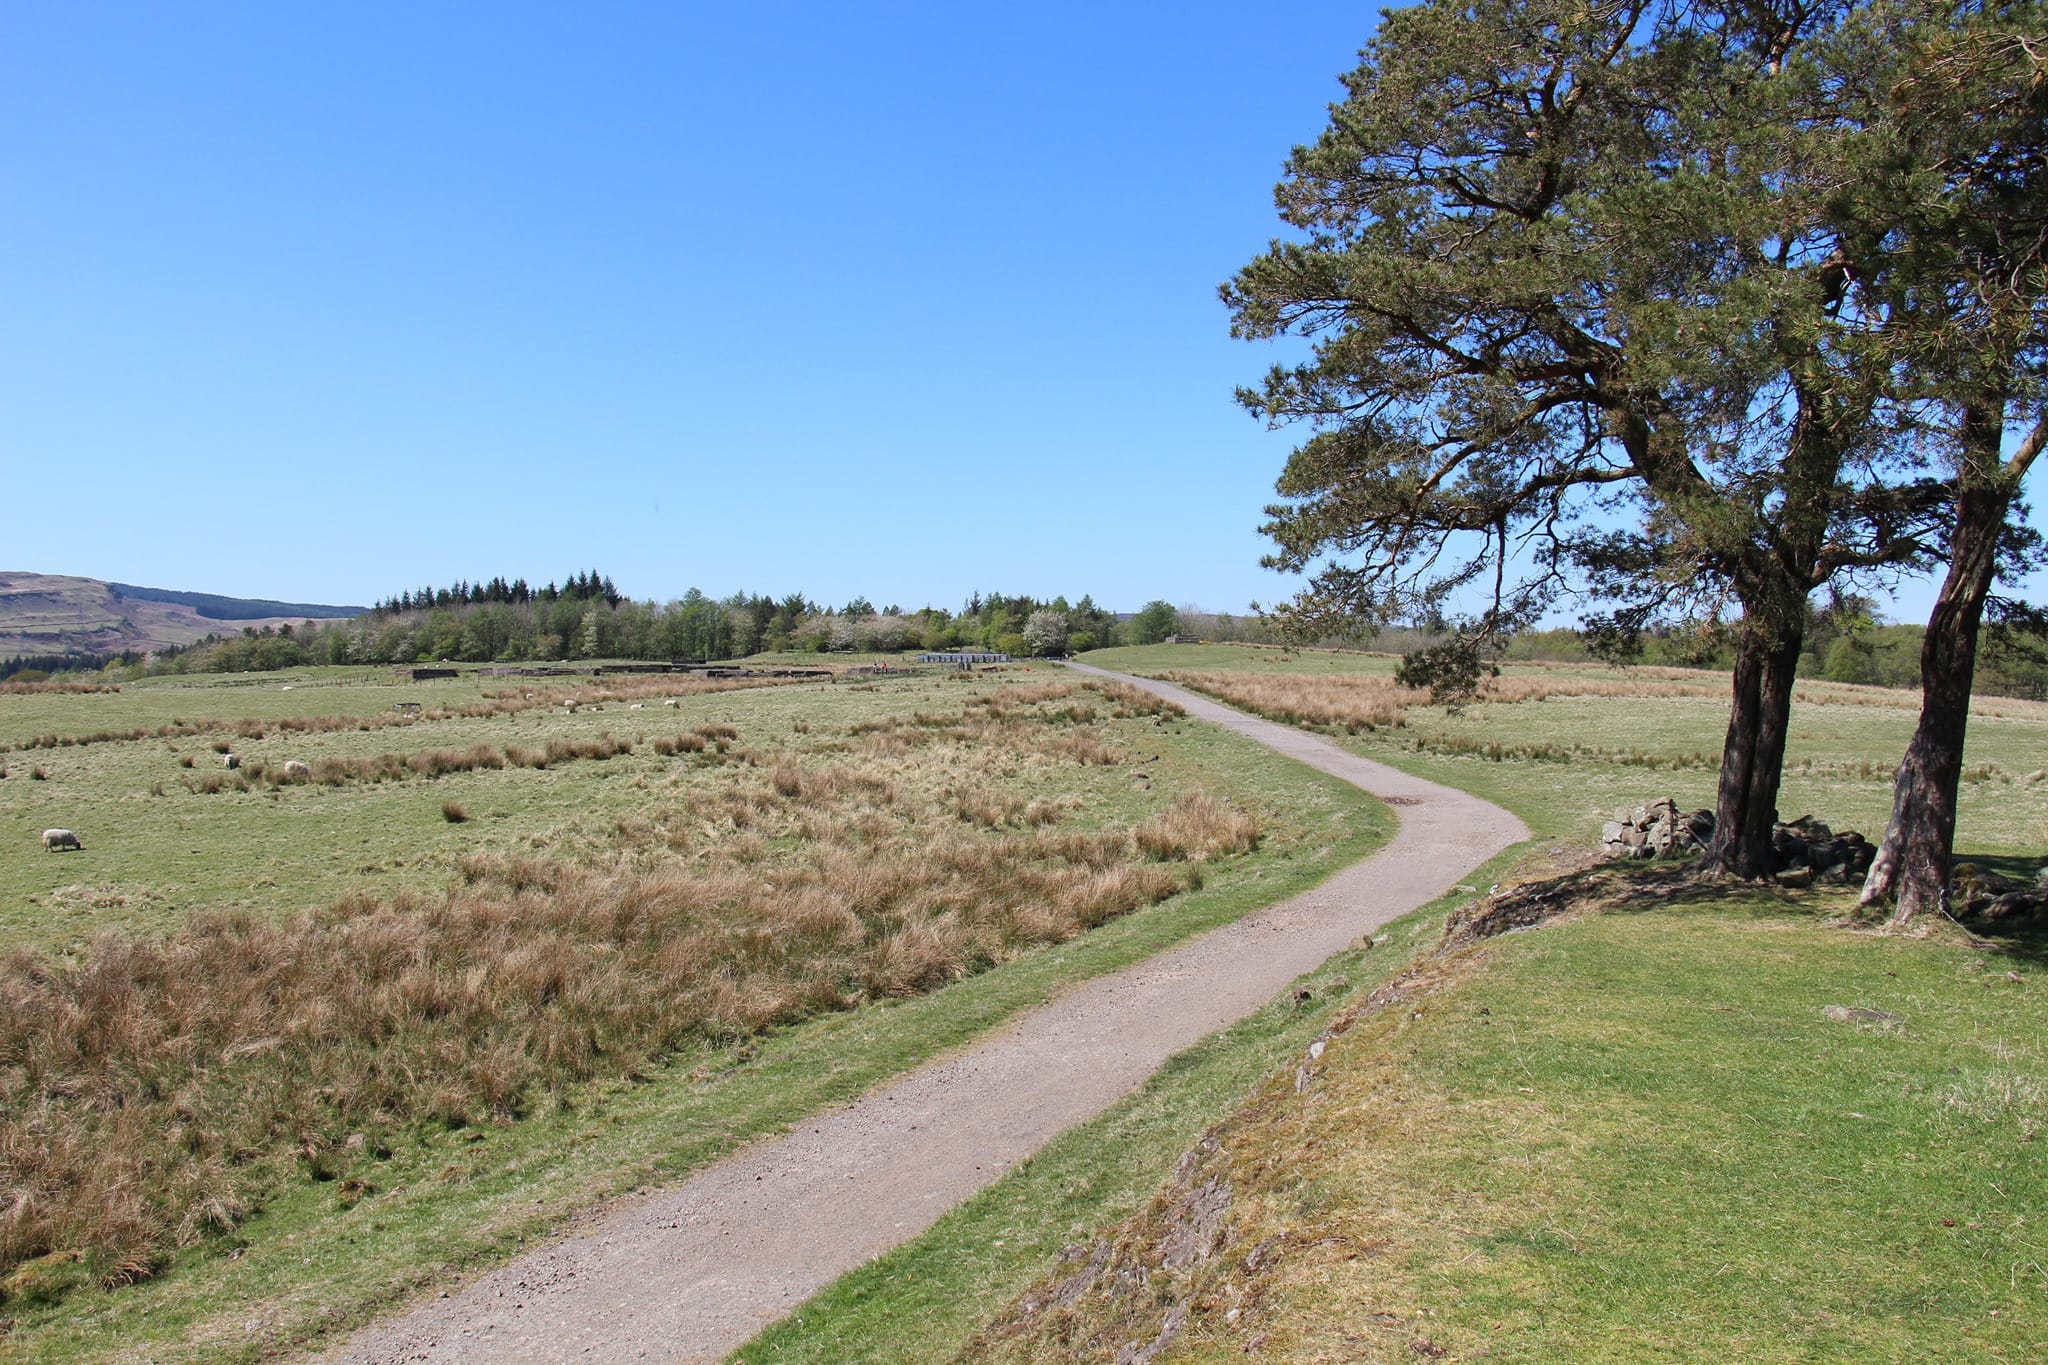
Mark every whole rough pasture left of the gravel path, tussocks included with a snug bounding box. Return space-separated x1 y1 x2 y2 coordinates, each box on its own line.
0 669 1382 1355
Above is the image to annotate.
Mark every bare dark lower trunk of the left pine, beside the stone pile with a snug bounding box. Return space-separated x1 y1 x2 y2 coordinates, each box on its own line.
1700 620 1800 878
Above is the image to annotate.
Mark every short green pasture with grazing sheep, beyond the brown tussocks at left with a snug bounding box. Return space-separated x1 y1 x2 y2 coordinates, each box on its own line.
0 669 815 948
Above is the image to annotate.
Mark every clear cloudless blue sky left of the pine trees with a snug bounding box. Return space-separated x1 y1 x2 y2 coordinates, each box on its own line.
0 0 2031 616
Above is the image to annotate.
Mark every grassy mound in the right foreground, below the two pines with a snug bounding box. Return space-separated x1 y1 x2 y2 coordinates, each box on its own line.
1056 890 2048 1363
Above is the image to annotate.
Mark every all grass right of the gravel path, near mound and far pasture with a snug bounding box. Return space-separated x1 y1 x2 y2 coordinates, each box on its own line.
735 647 2048 1365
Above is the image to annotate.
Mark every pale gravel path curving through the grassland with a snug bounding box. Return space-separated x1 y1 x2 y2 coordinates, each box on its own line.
330 663 1528 1363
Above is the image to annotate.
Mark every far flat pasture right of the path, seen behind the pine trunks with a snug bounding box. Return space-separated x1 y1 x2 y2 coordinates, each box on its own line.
1087 645 2048 855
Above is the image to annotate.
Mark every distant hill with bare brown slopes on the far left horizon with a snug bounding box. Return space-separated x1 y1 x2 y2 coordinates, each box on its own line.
0 571 365 659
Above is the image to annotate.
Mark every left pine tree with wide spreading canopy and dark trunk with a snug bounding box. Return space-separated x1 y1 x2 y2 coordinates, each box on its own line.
1223 0 2039 876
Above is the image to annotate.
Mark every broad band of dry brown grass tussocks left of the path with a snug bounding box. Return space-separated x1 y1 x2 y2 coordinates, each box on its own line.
0 694 1257 1285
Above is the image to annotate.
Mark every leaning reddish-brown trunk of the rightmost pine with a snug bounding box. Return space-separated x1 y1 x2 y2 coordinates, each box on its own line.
1860 405 2042 925
